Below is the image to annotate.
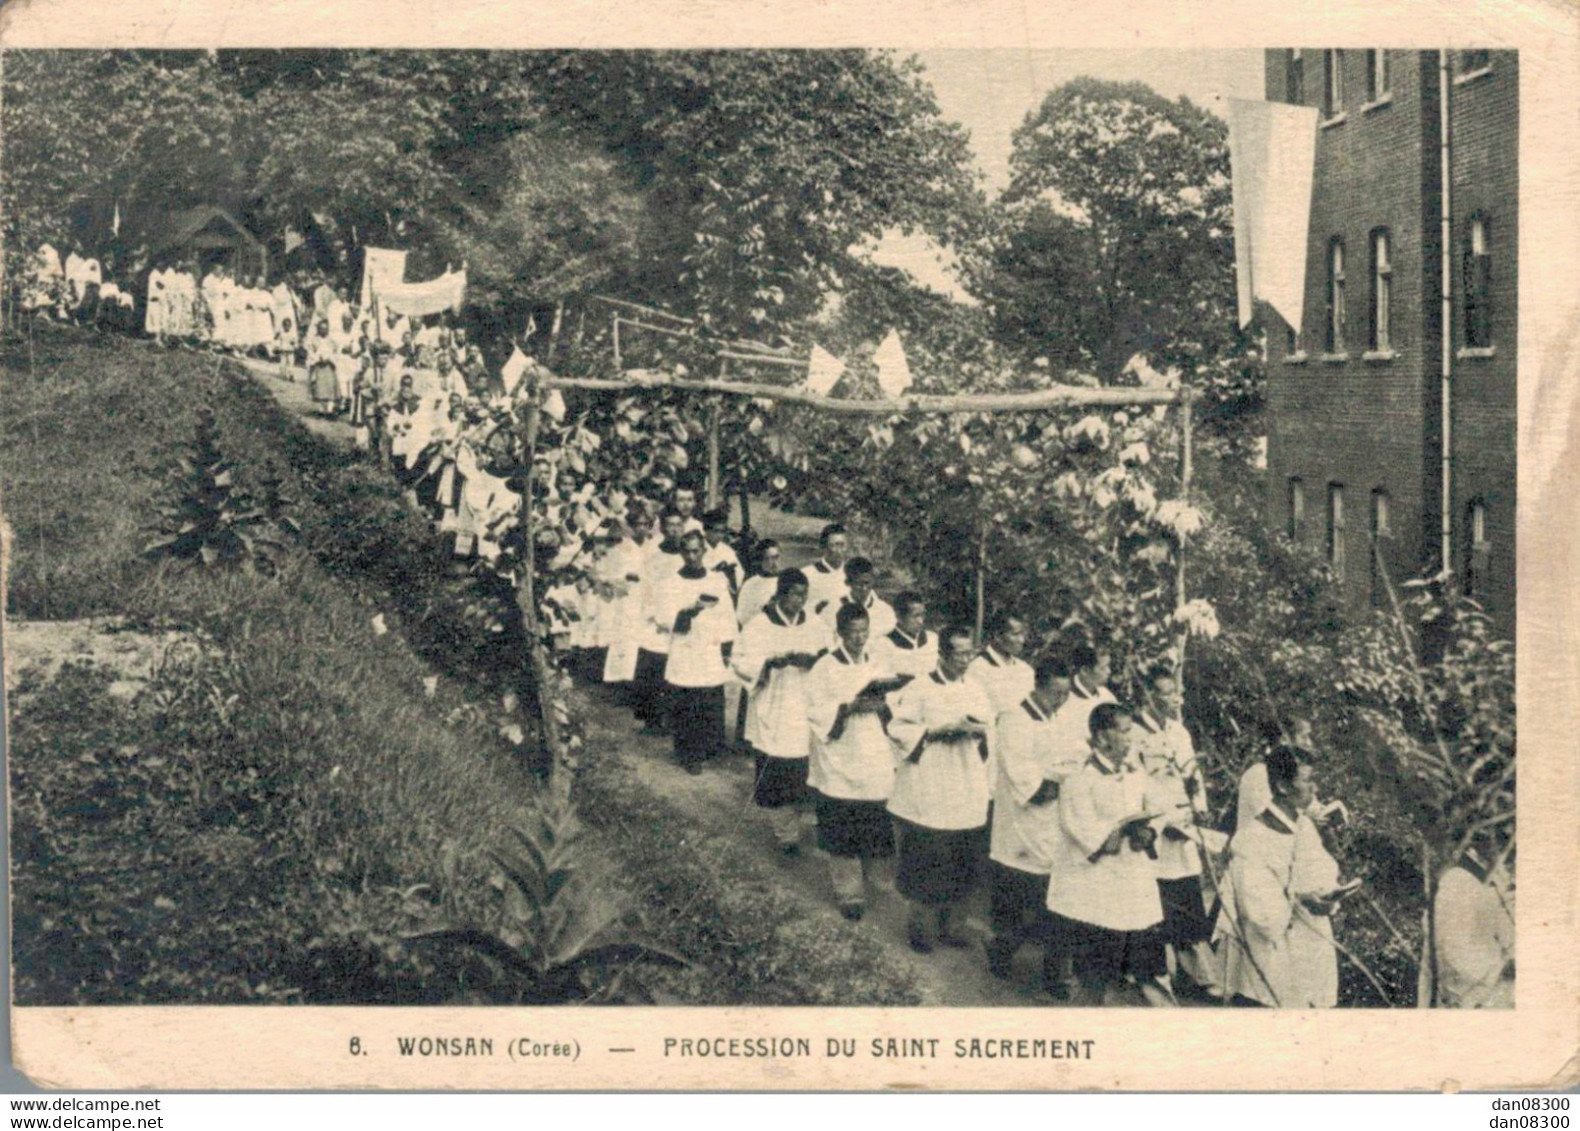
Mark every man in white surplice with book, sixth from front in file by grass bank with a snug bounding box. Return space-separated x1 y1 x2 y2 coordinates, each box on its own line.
649 531 735 774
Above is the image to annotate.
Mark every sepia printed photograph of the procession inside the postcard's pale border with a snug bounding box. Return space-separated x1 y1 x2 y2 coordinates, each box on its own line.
0 0 1556 1093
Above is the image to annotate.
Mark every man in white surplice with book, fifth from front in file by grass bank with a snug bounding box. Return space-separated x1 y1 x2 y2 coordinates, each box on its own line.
730 569 823 855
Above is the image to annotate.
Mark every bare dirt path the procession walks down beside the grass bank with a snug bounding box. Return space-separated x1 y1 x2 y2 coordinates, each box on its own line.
233 353 1054 1006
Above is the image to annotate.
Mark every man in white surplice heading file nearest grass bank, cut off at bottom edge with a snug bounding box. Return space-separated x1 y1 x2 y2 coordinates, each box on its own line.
1048 703 1168 1005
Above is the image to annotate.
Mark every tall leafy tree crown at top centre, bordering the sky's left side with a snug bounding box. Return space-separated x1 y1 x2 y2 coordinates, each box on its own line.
536 51 981 336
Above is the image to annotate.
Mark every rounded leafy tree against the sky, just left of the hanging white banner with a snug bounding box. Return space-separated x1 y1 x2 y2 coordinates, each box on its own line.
978 77 1236 384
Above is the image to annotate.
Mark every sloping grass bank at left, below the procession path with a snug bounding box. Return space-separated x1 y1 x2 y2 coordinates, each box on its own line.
0 326 913 1005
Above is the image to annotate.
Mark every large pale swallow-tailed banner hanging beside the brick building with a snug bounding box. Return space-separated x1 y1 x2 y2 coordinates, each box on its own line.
1228 98 1316 329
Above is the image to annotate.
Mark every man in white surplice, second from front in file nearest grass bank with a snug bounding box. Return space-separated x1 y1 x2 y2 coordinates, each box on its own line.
988 654 1070 994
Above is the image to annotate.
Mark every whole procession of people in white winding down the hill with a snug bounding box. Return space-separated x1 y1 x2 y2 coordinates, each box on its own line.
22 236 1514 1008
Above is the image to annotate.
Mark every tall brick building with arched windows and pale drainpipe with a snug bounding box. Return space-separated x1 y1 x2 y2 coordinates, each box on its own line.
1266 49 1518 635
